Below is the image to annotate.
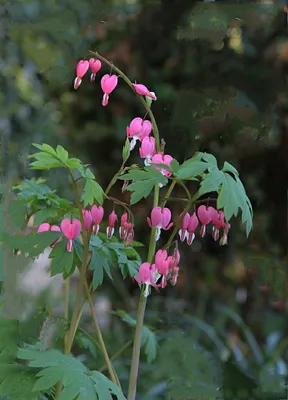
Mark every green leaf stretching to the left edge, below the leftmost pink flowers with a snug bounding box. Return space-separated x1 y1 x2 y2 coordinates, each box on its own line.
2 231 61 257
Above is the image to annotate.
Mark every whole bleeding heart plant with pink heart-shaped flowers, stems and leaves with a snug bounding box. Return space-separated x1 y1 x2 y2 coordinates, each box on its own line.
6 52 252 400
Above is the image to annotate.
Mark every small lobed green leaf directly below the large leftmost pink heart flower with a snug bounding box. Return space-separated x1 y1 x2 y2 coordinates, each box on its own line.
49 240 73 277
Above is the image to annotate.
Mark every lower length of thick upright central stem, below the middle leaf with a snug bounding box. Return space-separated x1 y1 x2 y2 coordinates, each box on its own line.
128 185 159 400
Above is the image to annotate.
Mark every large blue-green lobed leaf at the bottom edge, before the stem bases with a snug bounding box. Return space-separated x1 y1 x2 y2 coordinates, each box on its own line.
18 346 126 400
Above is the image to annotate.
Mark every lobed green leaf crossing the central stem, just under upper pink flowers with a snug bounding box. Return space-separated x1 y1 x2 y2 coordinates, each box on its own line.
119 167 168 205
